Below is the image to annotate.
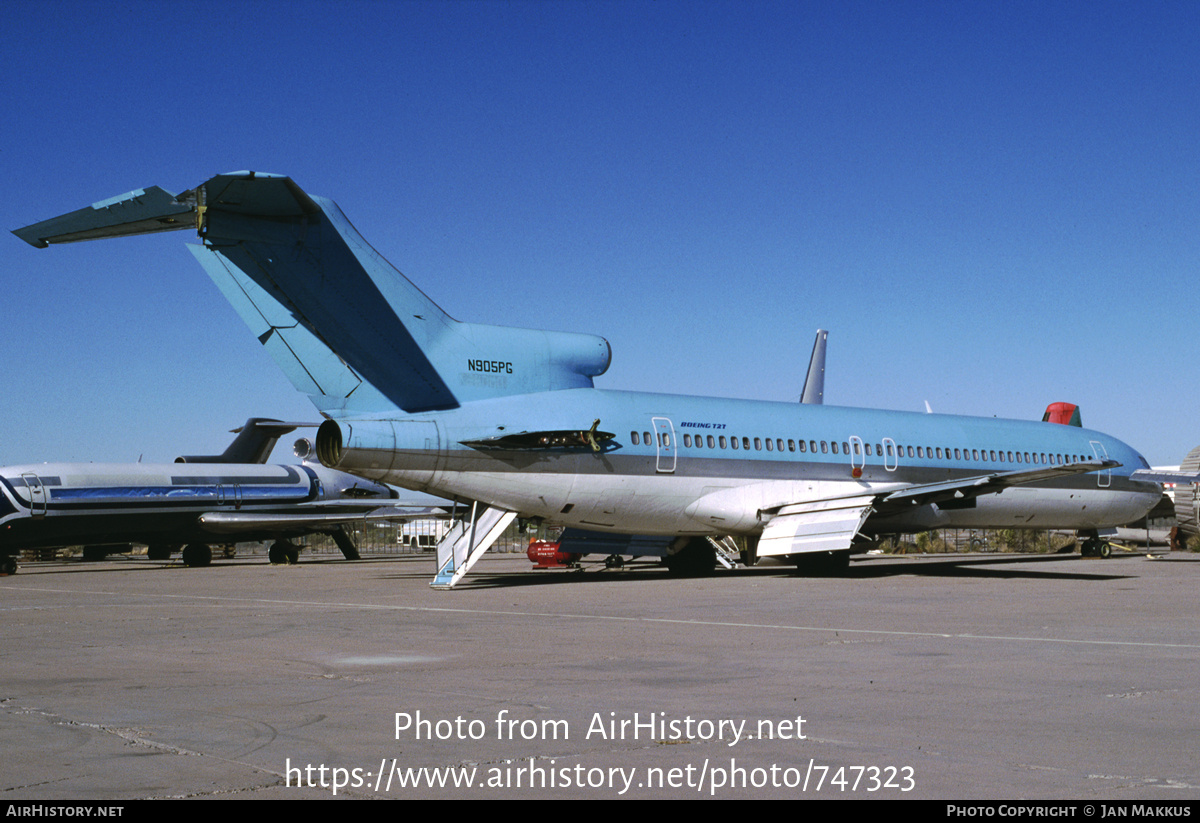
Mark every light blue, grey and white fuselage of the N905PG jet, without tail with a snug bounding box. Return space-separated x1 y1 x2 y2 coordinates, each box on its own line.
328 389 1160 535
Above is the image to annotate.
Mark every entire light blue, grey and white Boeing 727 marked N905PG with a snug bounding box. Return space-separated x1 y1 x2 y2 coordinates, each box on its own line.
9 172 1162 588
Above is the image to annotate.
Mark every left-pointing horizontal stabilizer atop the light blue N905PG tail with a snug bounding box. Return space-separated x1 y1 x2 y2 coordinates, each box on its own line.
13 186 196 248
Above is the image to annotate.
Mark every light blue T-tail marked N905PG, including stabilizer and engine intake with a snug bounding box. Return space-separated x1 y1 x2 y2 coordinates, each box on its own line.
14 172 611 416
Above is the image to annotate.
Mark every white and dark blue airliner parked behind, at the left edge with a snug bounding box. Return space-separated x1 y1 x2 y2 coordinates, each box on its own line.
0 417 420 573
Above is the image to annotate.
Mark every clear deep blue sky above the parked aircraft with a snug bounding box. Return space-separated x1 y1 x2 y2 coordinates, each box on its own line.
0 0 1200 464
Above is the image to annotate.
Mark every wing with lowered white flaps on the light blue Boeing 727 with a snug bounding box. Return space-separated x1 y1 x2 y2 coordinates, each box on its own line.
758 461 1120 557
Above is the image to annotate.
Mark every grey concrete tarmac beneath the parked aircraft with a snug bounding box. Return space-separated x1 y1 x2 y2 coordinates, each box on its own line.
0 554 1200 801
